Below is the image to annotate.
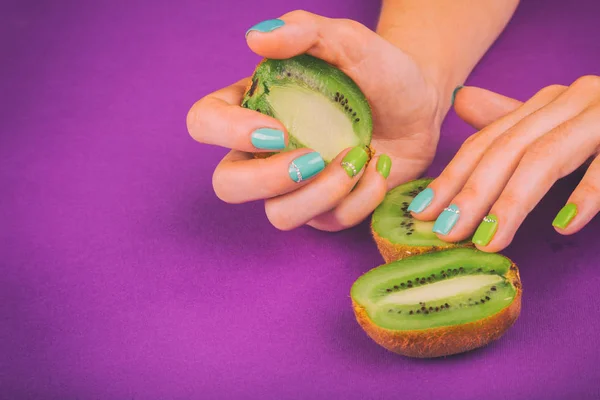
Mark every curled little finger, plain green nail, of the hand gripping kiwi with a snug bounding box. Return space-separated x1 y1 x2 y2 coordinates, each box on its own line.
308 155 391 232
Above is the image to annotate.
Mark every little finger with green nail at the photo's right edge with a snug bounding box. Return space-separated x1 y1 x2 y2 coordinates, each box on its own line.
552 156 600 235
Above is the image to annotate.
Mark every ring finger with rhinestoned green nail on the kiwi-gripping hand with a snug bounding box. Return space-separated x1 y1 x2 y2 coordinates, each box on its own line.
265 147 368 230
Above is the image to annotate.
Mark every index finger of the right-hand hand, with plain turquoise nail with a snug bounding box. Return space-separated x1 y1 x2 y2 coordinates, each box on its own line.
409 86 566 221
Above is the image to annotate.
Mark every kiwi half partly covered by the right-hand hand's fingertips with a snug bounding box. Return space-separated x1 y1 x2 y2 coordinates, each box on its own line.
371 178 473 262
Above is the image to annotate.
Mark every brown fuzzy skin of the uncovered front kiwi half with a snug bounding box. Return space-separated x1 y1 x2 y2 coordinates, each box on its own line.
352 263 523 358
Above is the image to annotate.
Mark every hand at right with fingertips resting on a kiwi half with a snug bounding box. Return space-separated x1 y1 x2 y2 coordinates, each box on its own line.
409 76 600 252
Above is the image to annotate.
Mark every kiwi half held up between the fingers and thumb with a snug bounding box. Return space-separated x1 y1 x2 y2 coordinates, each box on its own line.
242 55 373 163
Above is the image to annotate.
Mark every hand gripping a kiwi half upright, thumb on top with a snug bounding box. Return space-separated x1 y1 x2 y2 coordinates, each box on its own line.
187 11 450 231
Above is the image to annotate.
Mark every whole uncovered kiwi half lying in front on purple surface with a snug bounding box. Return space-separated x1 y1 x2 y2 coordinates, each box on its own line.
351 248 522 358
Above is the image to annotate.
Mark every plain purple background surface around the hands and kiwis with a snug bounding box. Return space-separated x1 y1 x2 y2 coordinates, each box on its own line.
0 0 600 400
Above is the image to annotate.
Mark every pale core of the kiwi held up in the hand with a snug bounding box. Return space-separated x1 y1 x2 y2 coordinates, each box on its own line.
268 85 360 161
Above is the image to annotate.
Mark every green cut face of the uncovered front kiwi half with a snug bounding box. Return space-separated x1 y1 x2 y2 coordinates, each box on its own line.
351 249 520 331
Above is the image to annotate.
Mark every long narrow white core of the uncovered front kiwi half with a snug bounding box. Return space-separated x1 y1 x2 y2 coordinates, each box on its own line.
382 275 503 305
